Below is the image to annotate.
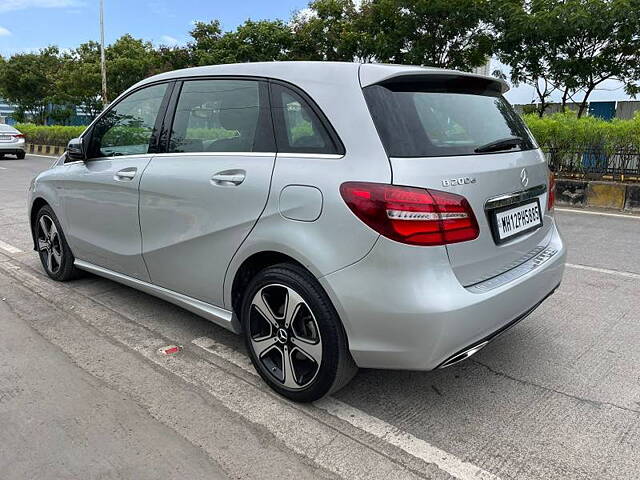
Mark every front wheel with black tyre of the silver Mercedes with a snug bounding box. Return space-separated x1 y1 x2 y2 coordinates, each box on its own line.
33 205 80 282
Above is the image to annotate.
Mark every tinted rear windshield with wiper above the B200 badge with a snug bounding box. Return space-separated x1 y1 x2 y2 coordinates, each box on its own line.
364 77 536 157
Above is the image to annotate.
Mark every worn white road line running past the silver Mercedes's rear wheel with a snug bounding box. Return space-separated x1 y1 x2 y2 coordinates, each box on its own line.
191 337 499 480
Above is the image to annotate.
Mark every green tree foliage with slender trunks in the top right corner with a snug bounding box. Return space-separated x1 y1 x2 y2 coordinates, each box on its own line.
492 0 640 116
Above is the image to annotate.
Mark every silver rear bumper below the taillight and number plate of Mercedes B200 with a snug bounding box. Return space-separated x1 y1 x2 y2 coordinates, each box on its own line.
320 219 566 370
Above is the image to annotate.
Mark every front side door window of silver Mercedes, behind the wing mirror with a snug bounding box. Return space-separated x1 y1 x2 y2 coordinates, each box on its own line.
89 84 167 158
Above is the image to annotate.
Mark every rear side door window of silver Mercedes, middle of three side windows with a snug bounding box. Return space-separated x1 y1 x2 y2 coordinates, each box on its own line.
169 80 275 153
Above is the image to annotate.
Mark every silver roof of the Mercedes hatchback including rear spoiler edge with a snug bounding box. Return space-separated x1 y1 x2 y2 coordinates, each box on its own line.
132 61 509 93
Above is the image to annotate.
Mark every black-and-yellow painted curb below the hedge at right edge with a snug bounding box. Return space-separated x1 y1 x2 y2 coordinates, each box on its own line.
556 178 640 212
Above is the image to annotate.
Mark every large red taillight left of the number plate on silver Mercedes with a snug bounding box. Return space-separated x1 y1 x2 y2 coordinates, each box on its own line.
340 182 480 245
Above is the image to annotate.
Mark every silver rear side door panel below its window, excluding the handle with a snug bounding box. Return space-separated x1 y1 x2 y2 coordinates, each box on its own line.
140 153 275 306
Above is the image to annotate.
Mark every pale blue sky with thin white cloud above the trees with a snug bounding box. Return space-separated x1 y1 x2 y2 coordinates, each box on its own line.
0 0 628 103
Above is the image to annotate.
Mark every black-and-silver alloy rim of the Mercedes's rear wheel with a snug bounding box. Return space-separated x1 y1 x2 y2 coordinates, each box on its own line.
249 284 322 390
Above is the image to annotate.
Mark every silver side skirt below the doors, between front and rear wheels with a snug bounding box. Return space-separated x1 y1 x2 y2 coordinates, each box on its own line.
74 259 241 333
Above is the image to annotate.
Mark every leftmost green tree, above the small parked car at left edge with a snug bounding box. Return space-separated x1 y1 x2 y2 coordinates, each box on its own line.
0 47 60 124
